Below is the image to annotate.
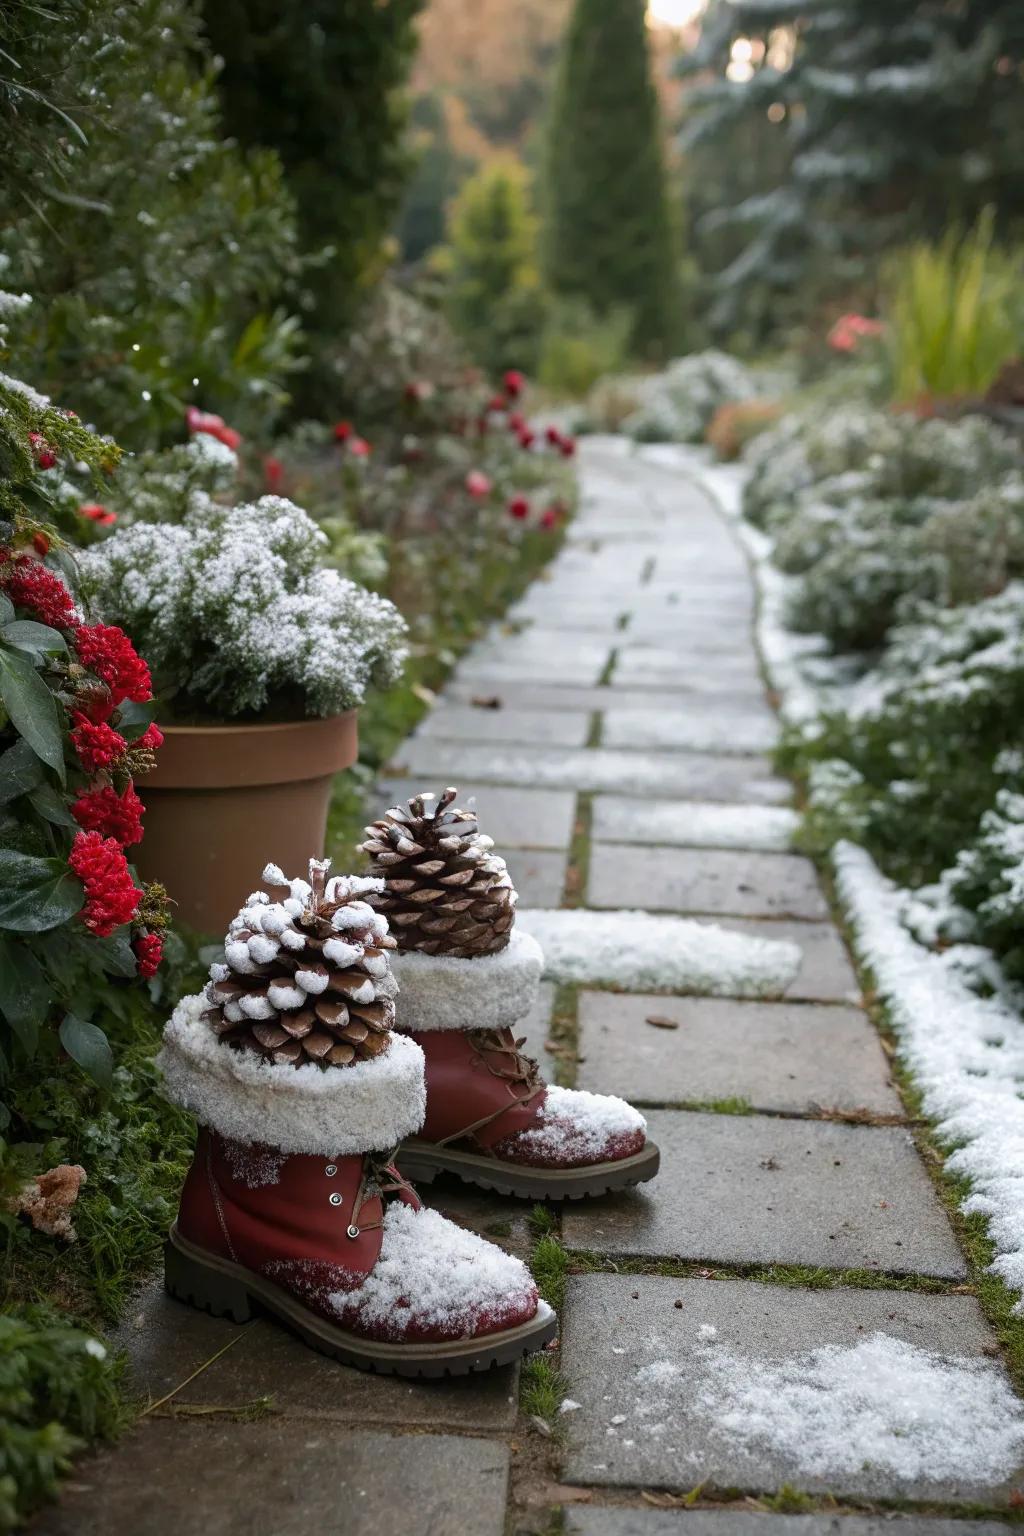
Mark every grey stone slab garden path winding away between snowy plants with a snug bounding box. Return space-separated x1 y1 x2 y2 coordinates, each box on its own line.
38 441 1012 1536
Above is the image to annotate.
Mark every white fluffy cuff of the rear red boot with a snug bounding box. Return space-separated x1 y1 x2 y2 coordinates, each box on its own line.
391 929 543 1029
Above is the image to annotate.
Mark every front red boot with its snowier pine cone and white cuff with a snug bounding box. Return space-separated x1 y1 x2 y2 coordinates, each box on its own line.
158 860 556 1376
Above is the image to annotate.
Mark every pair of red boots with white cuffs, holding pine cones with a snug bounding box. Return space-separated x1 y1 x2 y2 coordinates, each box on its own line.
158 791 659 1376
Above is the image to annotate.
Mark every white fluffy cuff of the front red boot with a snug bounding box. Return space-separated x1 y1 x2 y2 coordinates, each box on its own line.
157 995 427 1157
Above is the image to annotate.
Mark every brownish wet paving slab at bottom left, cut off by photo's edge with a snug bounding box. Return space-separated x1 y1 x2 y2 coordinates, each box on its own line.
32 1418 508 1536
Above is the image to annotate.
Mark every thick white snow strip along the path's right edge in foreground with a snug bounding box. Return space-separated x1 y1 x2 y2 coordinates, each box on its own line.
832 843 1024 1312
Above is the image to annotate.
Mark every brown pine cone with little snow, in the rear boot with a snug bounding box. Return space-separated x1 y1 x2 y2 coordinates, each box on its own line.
361 790 516 960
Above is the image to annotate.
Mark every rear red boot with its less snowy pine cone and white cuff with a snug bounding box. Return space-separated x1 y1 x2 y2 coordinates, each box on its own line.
362 790 659 1200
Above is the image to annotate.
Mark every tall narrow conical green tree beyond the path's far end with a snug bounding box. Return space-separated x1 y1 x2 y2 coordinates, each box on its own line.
543 0 679 356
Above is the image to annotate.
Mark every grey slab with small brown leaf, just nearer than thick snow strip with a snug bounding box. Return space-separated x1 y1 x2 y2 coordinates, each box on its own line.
577 992 903 1115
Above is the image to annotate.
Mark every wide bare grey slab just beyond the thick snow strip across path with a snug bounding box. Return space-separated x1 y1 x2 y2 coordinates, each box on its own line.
586 847 829 920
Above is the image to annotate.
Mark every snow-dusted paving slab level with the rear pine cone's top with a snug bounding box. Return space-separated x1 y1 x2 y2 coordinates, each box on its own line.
591 794 800 852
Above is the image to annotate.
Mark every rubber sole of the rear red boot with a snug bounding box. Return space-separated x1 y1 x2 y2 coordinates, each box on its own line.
396 1137 662 1200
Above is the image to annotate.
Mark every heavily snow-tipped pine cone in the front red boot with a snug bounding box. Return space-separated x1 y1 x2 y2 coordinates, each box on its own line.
199 859 398 1066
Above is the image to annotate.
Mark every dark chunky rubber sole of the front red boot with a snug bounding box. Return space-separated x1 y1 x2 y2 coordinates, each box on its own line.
164 1227 559 1379
